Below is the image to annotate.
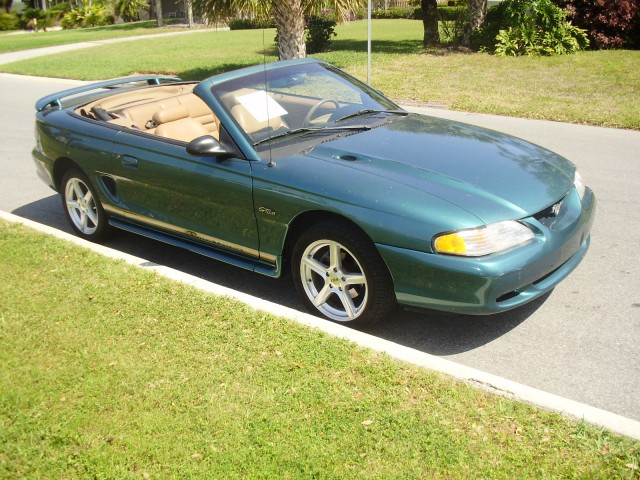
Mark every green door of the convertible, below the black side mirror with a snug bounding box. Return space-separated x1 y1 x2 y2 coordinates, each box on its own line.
113 130 259 257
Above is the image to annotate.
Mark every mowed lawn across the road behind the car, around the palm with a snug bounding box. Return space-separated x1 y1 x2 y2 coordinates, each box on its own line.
0 20 640 129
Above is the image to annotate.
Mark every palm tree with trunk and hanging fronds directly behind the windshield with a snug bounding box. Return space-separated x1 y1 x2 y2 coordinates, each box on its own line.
192 0 364 60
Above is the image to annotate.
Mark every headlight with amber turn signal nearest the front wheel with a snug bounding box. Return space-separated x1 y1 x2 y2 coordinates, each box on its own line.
433 220 533 257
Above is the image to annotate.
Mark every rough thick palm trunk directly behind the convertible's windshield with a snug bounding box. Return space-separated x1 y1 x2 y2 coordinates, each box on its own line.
272 0 307 60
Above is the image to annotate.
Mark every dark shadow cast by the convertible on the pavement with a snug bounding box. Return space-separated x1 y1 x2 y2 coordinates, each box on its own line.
12 195 549 356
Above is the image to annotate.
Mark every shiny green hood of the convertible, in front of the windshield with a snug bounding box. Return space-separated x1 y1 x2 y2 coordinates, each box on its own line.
306 114 575 223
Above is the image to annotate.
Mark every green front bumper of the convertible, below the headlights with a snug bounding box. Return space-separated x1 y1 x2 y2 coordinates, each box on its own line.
376 190 596 315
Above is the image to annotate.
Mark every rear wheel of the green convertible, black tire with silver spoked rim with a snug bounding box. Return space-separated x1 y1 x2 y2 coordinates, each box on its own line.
60 170 112 242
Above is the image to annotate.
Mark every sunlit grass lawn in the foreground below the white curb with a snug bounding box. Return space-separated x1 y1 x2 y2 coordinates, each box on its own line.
0 222 640 480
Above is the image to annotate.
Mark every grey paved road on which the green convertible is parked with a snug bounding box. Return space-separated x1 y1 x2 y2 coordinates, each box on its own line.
0 74 640 420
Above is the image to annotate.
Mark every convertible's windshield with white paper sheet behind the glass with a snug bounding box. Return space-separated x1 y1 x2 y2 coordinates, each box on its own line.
212 63 405 146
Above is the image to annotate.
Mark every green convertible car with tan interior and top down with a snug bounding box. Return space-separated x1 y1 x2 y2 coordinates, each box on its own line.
33 59 596 324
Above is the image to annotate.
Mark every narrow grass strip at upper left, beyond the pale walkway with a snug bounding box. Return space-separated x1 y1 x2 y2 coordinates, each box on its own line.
0 20 205 53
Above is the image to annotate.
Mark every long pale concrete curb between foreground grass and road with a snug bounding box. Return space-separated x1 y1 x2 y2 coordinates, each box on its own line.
0 211 640 440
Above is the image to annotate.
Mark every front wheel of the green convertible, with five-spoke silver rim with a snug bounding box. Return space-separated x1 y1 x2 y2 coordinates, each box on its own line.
291 221 396 326
